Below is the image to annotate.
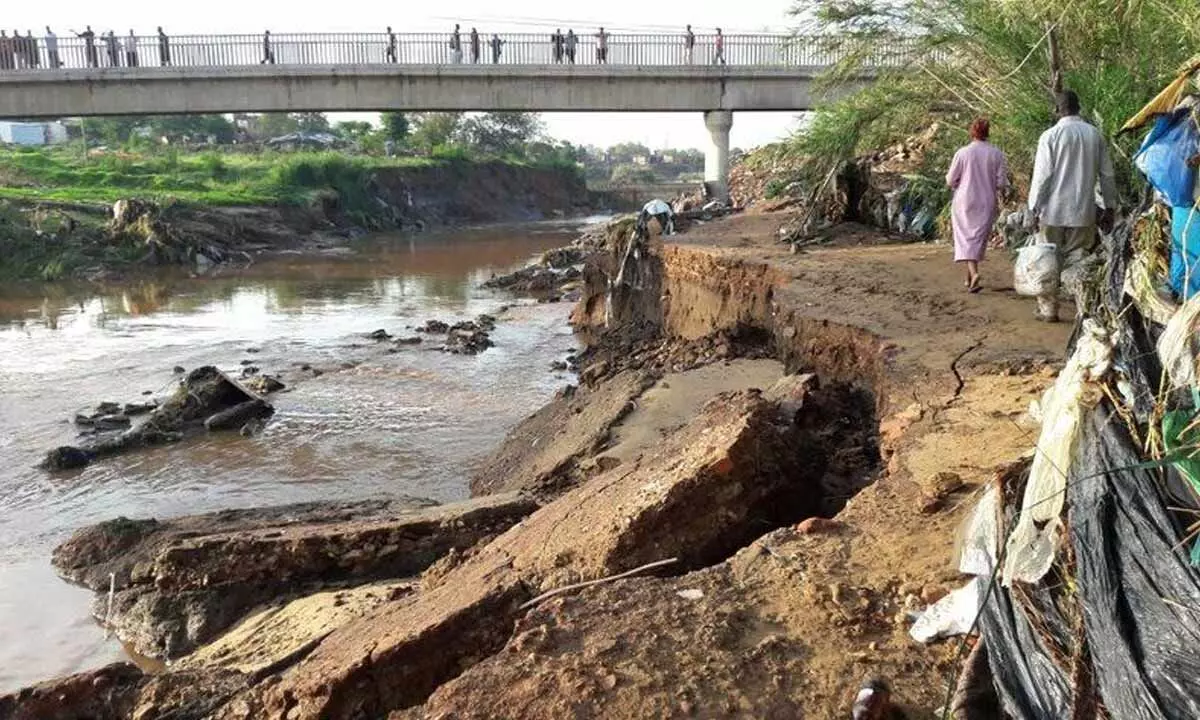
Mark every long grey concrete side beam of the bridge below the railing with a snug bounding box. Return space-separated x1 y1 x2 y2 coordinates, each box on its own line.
0 65 845 118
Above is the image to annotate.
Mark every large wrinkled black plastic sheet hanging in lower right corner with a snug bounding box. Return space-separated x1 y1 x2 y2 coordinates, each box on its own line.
1069 409 1200 718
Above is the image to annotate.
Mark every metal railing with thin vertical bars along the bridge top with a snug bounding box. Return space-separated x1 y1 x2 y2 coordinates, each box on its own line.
0 31 918 72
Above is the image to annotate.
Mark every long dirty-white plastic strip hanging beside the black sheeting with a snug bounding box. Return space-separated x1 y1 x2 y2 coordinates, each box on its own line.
1003 319 1112 587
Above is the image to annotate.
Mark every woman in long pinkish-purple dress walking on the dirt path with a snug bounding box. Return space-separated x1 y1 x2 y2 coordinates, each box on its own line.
946 118 1008 293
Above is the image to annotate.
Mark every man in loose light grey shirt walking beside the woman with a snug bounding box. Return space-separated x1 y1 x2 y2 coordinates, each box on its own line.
1030 90 1117 323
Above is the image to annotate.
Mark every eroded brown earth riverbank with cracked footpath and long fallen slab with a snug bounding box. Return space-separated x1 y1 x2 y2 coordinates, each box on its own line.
7 211 1067 718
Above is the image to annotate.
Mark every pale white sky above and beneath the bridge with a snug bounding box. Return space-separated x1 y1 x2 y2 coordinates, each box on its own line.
0 0 805 149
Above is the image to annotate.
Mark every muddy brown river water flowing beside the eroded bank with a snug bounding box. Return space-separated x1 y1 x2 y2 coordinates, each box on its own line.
0 223 577 692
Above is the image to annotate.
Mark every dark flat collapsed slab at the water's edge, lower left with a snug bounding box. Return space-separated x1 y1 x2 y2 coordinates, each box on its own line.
53 494 534 658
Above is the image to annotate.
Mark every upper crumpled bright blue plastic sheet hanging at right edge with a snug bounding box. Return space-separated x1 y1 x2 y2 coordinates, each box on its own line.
1133 108 1200 208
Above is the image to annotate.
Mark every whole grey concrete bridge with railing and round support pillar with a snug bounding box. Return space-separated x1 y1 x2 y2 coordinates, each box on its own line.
0 30 906 194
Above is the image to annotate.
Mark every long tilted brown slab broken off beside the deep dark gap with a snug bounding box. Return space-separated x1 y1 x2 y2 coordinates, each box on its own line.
221 391 816 719
